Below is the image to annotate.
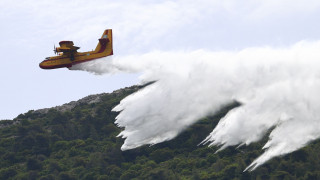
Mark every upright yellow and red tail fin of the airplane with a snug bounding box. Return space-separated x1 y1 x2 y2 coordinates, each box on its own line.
95 29 113 56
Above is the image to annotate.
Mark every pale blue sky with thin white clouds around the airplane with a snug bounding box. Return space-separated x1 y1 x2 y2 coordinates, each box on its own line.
0 0 320 119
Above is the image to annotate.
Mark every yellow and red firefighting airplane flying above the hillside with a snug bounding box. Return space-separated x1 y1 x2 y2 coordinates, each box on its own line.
39 29 113 69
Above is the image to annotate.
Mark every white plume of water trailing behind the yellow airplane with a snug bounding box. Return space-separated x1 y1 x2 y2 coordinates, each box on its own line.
72 42 320 170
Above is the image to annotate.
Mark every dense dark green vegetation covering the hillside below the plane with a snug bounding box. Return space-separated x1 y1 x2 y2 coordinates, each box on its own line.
0 88 320 180
